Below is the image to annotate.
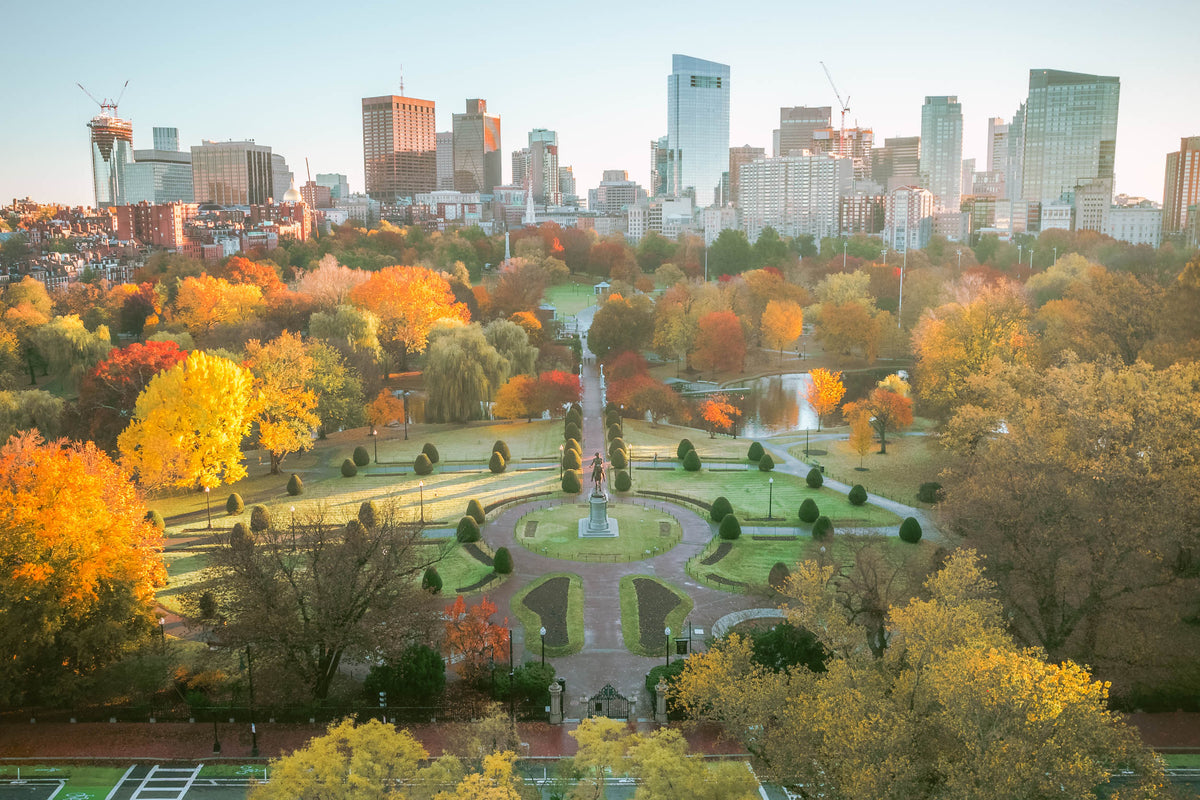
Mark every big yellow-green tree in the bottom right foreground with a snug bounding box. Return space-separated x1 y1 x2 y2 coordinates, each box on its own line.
676 551 1164 800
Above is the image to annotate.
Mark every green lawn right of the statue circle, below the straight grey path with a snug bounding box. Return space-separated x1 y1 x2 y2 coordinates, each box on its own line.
686 534 936 593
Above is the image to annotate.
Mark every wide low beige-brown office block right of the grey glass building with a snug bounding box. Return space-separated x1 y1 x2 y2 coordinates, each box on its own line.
192 139 274 205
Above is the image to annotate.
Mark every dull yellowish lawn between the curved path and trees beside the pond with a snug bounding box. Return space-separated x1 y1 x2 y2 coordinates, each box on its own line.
787 435 958 507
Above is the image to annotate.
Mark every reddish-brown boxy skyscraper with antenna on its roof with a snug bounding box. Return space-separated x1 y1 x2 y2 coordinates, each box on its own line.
362 95 438 203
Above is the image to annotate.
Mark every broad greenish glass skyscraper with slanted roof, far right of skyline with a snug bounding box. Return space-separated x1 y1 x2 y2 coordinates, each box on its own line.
1009 70 1121 203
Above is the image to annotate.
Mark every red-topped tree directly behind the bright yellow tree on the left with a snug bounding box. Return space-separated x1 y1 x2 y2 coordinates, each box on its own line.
79 342 187 452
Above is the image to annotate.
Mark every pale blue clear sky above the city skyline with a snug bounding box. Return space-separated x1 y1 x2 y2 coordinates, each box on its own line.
0 0 1200 205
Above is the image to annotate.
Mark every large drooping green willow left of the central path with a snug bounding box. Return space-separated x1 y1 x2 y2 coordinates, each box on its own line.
425 323 506 422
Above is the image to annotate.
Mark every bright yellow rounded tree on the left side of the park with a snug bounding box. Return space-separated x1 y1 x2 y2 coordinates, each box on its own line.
116 350 258 488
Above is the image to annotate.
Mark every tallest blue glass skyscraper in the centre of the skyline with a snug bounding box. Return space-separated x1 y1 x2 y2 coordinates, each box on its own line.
667 54 730 207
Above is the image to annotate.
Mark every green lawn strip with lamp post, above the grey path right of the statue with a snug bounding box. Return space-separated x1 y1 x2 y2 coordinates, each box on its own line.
634 468 900 528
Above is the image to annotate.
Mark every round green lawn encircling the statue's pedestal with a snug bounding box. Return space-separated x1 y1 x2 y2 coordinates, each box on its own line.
515 501 683 561
